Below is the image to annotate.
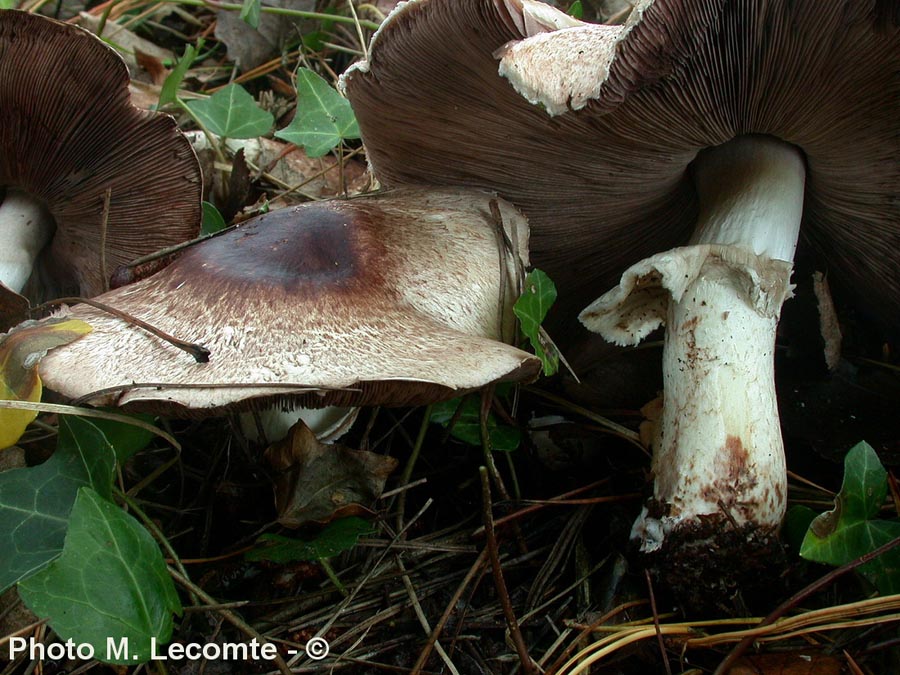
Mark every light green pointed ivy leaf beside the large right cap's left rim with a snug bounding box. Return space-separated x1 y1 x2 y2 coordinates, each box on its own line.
275 68 359 157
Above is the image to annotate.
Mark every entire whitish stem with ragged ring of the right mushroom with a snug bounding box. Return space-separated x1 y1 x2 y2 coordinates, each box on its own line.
582 136 805 552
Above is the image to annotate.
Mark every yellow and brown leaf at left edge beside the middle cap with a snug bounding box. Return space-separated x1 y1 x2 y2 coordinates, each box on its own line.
0 319 91 449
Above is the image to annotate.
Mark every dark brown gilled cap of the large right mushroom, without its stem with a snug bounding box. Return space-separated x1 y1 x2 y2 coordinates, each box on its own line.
344 0 900 322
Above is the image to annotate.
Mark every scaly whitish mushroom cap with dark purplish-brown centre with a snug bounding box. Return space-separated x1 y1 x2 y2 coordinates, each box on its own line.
40 190 540 416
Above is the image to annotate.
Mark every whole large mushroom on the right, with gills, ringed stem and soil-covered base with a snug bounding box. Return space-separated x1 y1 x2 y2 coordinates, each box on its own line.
344 0 900 603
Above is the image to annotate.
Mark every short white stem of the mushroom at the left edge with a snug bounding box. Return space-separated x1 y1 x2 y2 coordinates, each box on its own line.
0 188 55 293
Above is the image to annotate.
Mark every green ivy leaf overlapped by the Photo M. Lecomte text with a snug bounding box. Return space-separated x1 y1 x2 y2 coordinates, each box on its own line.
19 487 181 664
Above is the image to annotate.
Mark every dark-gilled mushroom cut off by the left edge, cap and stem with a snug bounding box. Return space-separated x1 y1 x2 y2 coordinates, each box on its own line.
0 10 201 330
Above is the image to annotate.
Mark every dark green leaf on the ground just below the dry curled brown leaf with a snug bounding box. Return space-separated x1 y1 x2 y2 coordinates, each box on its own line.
246 516 374 563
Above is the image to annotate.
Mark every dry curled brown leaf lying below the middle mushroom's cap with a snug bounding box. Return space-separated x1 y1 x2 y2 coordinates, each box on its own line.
266 421 397 527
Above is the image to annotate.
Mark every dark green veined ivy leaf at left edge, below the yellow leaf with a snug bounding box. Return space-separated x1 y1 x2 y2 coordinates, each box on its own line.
0 417 115 591
